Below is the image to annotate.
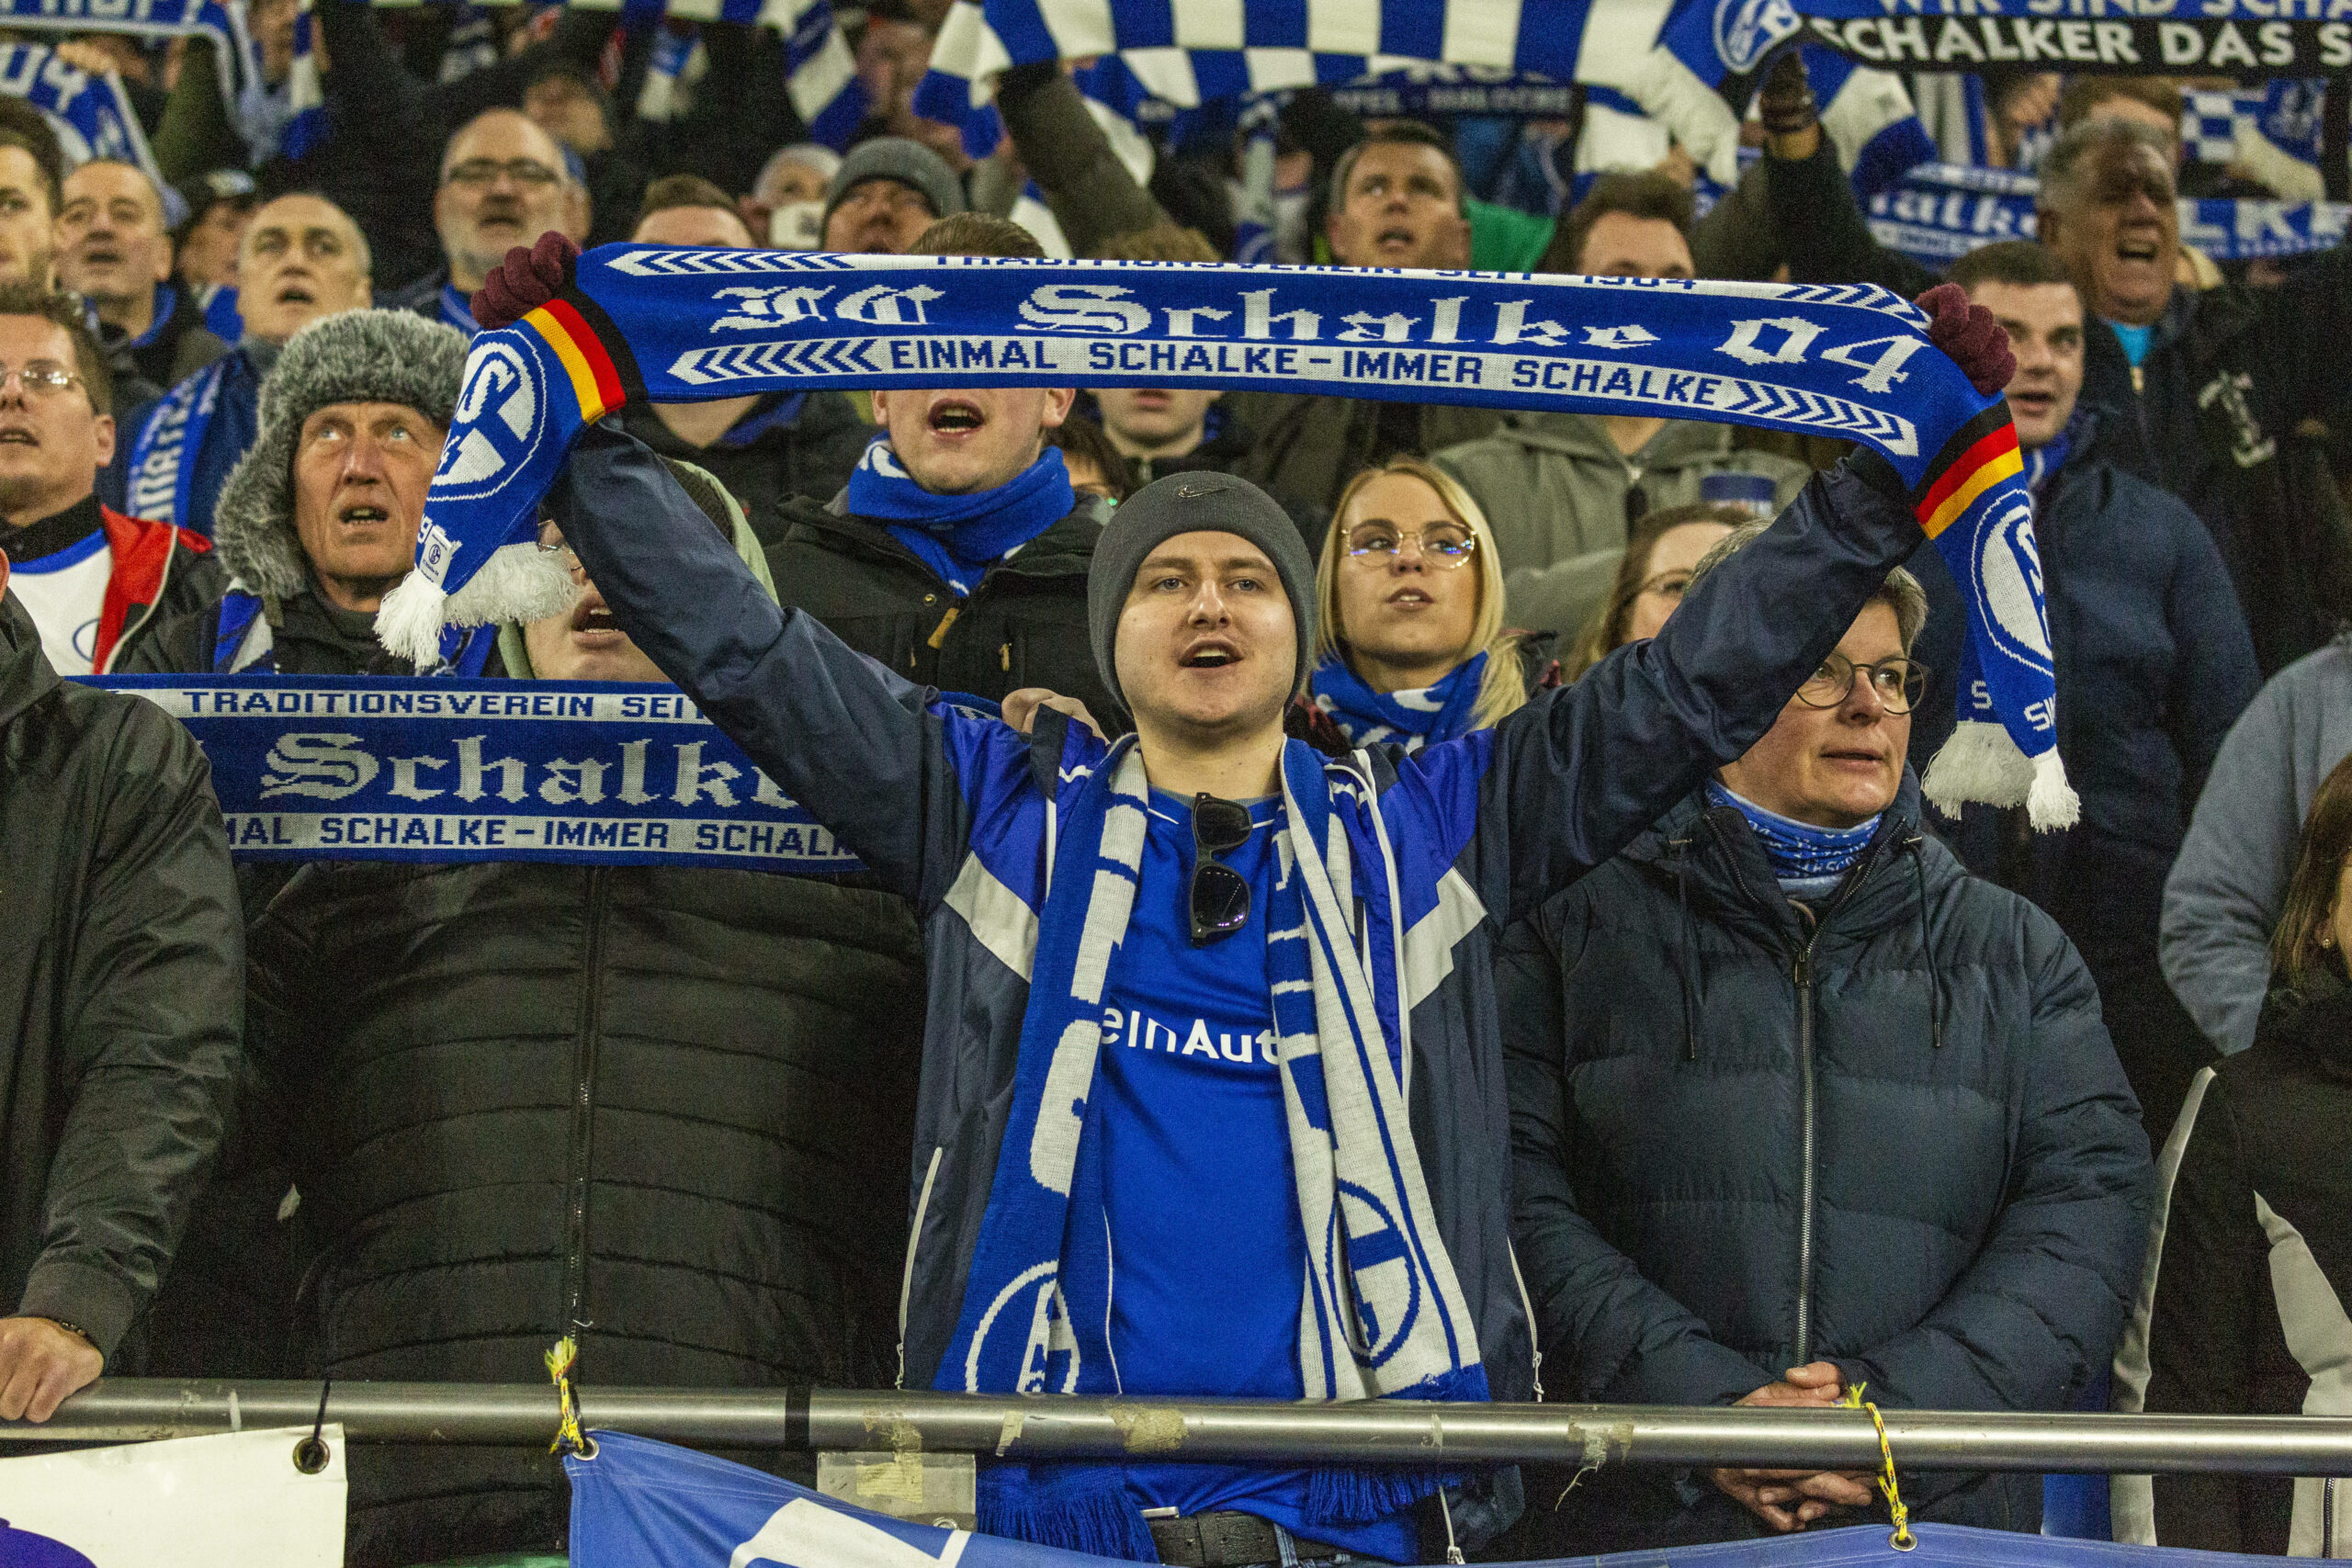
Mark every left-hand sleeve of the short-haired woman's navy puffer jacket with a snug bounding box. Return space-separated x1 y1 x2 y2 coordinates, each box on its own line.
1496 900 1773 1405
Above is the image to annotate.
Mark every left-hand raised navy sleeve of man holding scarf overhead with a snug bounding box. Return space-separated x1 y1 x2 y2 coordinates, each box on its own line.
548 425 969 905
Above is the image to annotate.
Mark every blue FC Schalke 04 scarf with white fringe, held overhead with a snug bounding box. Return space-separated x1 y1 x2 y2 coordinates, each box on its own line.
377 244 2075 825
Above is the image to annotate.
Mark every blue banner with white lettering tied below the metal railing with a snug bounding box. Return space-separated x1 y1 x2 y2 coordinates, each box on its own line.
564 1438 2279 1568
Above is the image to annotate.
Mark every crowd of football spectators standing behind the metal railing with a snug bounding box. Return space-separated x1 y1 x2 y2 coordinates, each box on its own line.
0 0 2352 1568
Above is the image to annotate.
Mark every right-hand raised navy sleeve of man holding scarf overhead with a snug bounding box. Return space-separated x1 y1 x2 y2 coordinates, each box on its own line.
1479 454 1924 924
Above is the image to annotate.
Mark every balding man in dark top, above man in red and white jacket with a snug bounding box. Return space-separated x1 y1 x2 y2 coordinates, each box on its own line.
56 157 228 388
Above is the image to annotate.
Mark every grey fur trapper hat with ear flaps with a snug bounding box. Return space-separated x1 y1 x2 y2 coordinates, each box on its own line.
211 310 466 597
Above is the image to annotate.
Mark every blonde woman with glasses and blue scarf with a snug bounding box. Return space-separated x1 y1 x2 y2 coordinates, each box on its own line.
1307 456 1557 752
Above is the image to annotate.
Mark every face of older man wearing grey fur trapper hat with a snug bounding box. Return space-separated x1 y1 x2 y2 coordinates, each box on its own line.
294 402 447 611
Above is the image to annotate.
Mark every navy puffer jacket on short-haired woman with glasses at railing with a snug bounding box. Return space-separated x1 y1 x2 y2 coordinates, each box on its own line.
1498 773 2152 1551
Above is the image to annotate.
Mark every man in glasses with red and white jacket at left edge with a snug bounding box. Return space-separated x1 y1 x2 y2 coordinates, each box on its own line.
0 282 223 674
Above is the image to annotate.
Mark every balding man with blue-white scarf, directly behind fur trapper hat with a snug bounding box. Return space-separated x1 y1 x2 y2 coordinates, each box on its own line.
125 190 374 536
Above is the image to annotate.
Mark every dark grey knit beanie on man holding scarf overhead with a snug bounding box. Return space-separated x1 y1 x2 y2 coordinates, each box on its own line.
1087 472 1315 707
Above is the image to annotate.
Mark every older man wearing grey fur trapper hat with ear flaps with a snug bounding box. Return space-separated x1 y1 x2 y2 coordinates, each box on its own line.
125 310 494 674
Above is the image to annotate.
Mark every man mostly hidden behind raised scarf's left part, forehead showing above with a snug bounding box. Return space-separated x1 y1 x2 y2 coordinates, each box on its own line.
614 174 873 546
